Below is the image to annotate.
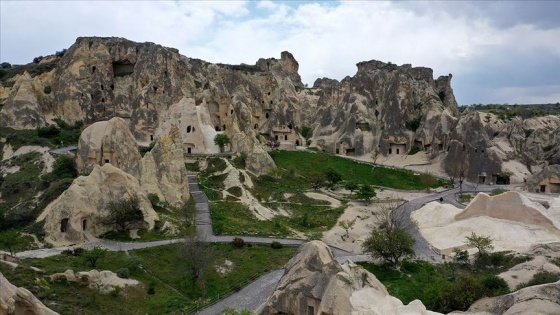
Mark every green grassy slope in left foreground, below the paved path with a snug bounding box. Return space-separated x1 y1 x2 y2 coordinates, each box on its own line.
0 244 296 315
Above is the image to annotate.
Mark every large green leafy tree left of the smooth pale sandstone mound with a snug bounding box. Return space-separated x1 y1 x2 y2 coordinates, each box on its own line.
362 202 415 266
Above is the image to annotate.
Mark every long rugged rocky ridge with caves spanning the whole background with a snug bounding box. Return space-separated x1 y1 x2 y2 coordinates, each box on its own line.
0 37 560 183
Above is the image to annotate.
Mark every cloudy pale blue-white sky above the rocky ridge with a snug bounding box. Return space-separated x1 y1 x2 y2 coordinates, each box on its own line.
0 0 560 105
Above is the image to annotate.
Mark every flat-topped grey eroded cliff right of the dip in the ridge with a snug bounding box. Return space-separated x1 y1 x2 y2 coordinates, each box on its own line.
314 60 458 156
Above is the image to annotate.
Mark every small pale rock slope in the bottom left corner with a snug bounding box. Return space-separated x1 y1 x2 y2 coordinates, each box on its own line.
0 272 58 315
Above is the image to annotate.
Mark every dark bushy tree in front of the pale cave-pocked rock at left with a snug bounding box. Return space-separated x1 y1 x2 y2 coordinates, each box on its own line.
101 196 144 232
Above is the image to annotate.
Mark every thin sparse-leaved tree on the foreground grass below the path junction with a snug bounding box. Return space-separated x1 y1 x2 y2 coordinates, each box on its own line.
179 234 212 291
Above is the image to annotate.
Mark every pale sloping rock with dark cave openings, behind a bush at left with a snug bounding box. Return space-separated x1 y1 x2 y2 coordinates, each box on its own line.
37 164 158 245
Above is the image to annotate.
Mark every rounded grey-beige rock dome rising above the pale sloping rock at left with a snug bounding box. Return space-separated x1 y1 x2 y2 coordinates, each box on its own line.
76 117 141 179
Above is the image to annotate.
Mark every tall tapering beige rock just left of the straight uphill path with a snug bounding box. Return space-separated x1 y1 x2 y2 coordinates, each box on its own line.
141 126 189 207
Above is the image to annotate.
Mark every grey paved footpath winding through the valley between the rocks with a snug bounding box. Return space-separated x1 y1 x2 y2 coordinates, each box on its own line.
10 176 496 315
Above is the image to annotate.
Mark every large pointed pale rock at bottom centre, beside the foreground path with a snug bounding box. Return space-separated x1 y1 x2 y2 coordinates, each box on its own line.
257 241 438 315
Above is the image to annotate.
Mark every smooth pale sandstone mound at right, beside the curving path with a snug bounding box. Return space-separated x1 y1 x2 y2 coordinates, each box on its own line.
412 192 560 255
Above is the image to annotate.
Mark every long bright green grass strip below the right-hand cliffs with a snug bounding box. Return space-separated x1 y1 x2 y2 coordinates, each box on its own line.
270 151 445 190
